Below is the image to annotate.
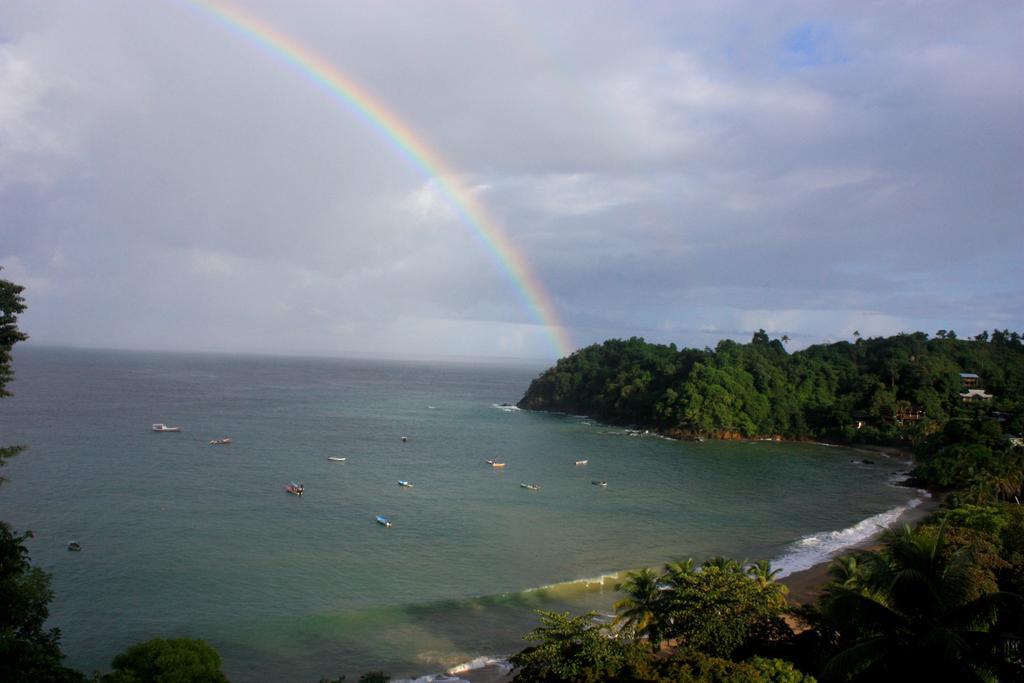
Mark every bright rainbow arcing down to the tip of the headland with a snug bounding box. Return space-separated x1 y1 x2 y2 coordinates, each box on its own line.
184 0 573 357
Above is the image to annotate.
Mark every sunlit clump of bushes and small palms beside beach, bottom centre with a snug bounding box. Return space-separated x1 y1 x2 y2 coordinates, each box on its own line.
511 558 815 683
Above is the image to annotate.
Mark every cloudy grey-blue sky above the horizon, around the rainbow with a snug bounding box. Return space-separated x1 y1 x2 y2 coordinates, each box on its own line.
0 0 1024 358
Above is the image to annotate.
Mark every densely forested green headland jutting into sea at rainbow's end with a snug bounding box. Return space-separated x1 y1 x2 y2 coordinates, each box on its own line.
519 331 1024 444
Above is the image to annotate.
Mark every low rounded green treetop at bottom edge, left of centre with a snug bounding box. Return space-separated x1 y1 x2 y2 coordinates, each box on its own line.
102 638 227 683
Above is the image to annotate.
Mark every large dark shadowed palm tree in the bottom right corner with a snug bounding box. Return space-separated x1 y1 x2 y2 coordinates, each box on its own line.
822 523 1024 681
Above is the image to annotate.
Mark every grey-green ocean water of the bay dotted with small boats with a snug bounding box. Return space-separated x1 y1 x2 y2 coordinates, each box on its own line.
0 346 920 681
